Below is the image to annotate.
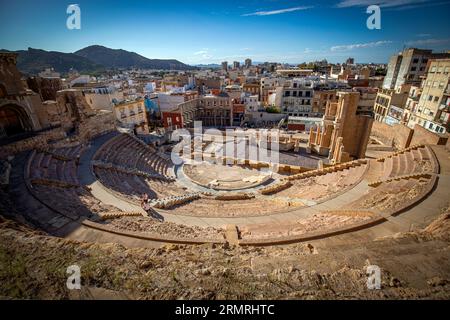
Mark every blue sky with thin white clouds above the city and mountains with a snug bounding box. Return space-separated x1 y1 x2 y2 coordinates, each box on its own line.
0 0 450 64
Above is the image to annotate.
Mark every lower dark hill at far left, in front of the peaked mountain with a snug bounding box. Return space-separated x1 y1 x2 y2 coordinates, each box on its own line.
9 48 104 75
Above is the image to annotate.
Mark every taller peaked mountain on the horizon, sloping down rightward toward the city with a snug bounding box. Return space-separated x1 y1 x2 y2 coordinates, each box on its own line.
74 45 195 70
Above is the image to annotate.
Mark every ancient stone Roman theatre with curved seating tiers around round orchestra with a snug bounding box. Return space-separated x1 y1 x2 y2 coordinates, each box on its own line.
1 130 450 247
